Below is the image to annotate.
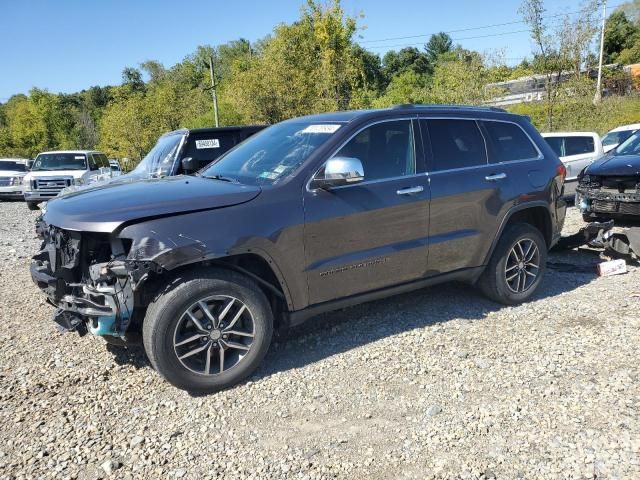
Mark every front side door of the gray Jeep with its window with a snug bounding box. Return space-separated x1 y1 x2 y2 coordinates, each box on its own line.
304 119 429 304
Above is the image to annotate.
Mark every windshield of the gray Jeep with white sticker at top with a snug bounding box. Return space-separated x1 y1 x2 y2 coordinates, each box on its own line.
200 122 340 185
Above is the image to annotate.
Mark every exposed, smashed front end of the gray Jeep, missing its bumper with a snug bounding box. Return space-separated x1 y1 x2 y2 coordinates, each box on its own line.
31 220 157 340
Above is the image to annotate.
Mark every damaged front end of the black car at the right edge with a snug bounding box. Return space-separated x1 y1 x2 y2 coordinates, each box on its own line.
576 173 640 218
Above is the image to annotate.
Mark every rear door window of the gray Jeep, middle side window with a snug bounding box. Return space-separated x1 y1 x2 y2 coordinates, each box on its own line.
422 119 487 172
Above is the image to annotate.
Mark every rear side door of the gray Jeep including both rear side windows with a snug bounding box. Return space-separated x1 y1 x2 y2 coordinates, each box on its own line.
420 118 541 274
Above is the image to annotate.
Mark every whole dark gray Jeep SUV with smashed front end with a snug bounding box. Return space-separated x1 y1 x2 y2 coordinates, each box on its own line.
31 105 566 392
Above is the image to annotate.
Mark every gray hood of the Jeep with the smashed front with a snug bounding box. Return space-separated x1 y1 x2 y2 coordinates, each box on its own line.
44 175 261 232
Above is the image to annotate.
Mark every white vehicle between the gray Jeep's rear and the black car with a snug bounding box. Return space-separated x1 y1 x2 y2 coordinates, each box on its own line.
542 132 604 198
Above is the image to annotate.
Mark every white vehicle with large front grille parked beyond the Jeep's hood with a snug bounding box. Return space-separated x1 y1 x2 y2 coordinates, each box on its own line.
23 150 111 210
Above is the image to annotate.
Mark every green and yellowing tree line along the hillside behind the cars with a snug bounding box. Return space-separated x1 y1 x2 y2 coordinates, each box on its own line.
0 0 640 161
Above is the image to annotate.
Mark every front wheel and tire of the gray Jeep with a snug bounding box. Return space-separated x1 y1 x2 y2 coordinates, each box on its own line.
142 269 273 393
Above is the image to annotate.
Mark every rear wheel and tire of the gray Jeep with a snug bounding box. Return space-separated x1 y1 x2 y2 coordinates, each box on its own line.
478 223 547 305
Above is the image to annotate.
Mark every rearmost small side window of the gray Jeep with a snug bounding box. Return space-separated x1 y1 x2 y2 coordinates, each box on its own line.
481 121 538 163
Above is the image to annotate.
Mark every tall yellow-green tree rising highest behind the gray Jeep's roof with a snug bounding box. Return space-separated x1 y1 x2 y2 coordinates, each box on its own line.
226 0 366 123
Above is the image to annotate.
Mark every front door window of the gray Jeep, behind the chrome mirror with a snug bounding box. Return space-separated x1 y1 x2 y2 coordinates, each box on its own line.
335 120 416 180
